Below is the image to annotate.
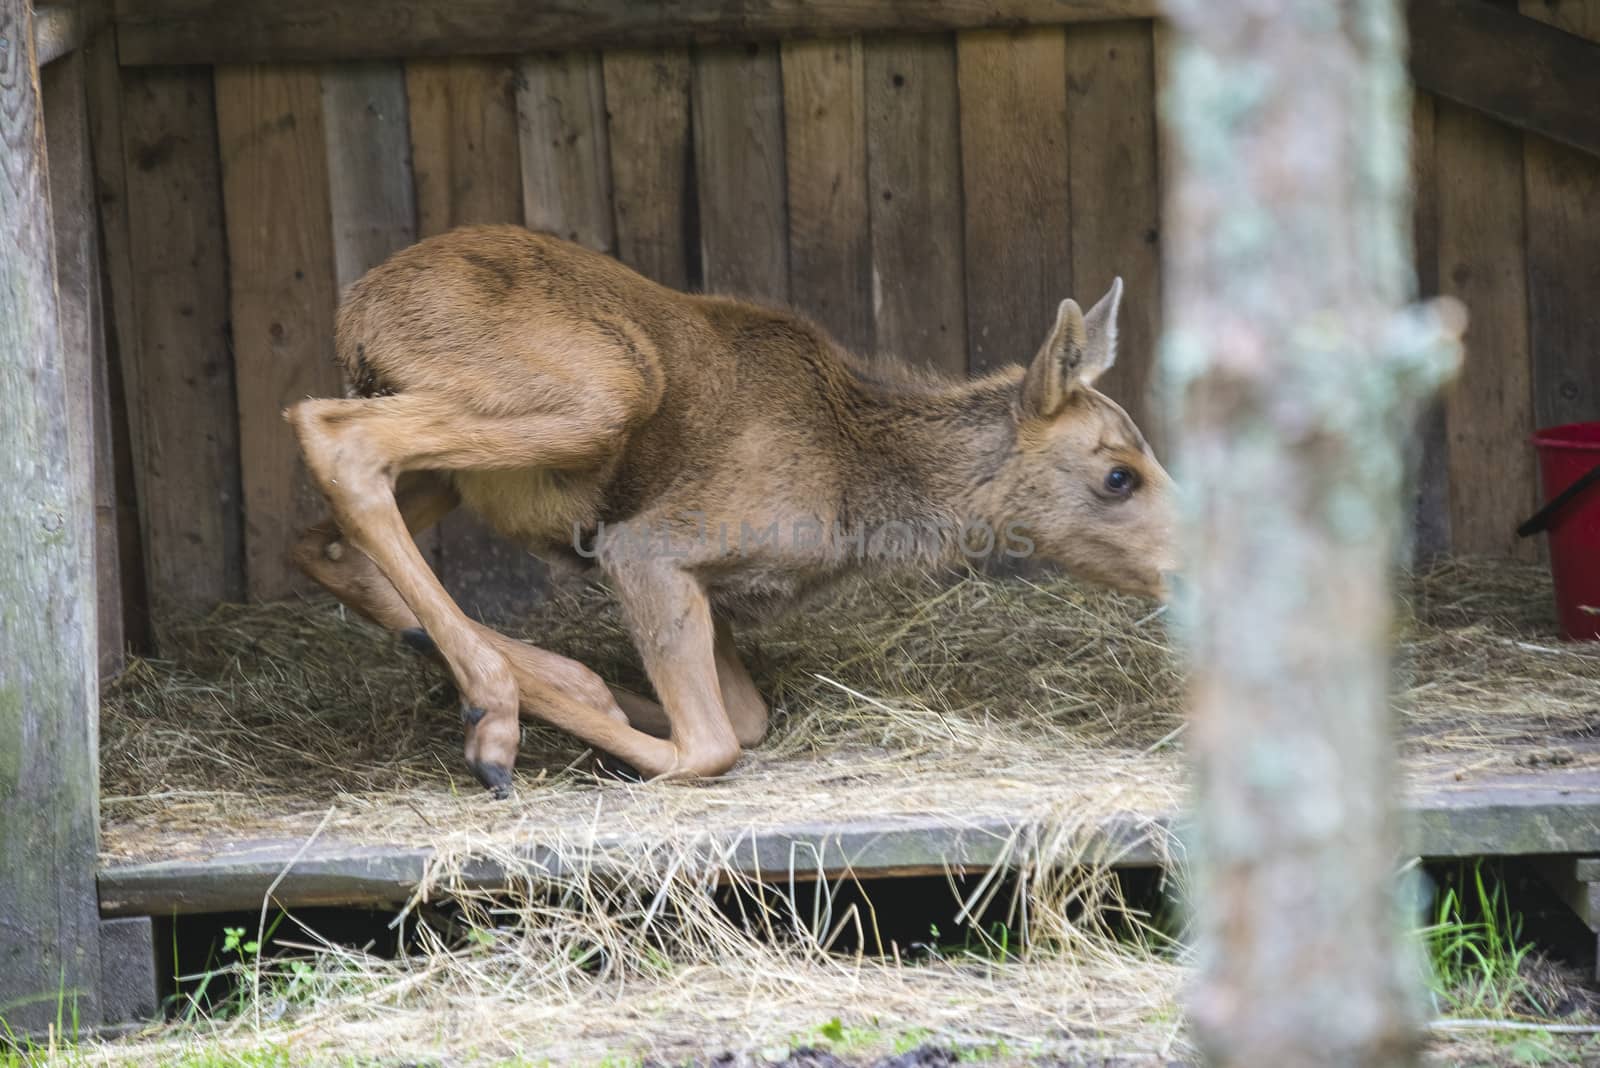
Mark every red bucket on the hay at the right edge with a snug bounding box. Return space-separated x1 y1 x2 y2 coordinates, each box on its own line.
1518 422 1600 641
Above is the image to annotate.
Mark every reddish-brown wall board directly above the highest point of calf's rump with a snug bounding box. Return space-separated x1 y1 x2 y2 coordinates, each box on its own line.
405 59 522 237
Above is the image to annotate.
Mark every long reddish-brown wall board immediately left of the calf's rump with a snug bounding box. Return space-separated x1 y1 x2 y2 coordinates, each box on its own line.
216 66 341 600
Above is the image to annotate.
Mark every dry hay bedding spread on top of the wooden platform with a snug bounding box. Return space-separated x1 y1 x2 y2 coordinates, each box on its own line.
101 561 1600 857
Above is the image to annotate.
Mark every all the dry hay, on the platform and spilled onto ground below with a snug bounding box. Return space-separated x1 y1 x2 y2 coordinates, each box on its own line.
87 561 1600 1063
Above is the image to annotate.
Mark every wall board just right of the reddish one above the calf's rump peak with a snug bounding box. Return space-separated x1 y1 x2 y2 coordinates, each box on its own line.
517 51 616 253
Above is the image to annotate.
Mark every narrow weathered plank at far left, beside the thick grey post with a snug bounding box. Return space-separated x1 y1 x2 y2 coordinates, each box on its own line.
40 53 123 678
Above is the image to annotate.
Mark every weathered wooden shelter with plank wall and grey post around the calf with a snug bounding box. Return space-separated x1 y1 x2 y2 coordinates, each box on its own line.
0 0 1600 1023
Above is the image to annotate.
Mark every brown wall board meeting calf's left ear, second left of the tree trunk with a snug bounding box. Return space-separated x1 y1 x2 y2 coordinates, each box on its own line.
955 29 1072 371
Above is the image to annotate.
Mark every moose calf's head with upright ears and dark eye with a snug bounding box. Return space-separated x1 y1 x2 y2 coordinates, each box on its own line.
995 278 1176 596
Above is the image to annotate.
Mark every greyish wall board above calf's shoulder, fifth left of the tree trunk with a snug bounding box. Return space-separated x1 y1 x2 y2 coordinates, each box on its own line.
691 43 789 304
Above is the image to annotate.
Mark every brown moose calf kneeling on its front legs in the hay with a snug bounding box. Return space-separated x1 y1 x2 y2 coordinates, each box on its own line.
285 227 1173 796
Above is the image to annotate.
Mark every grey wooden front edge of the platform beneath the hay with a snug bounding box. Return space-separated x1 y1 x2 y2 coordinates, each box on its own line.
99 769 1600 916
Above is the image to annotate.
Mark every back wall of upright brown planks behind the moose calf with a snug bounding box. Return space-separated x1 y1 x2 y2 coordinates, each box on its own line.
84 10 1600 633
